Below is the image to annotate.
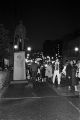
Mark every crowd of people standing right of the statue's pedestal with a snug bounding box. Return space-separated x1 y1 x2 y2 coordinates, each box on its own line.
26 58 80 91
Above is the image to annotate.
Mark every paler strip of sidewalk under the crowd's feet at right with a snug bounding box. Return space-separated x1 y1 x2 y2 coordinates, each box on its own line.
49 85 80 96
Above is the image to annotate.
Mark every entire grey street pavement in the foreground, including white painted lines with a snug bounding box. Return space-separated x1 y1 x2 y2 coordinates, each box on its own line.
0 83 80 120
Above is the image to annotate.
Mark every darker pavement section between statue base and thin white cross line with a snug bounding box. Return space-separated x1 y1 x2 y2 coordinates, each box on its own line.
2 83 57 99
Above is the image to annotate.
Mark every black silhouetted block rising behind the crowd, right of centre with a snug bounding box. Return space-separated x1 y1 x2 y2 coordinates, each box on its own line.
43 40 63 56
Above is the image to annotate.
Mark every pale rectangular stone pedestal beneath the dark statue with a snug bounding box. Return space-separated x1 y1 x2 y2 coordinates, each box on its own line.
13 51 26 80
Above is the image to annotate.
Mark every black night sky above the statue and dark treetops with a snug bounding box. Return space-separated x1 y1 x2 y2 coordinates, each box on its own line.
0 0 80 48
